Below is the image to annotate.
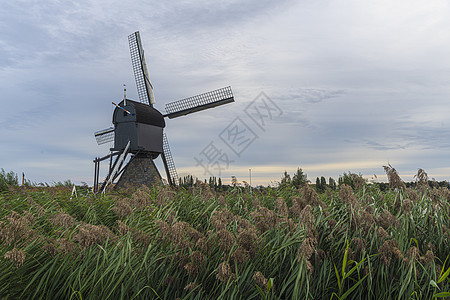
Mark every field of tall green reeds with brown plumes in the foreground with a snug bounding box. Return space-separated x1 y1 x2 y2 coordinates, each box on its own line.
0 174 450 299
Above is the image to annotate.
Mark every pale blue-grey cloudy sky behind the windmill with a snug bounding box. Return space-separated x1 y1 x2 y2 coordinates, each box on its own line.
0 0 450 185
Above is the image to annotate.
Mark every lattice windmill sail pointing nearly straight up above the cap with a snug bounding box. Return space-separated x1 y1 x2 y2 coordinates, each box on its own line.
128 31 155 105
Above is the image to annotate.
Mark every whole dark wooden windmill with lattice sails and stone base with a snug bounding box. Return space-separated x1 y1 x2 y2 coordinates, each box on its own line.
94 31 234 192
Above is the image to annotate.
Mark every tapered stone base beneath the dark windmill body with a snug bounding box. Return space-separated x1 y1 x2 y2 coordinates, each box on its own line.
115 154 162 189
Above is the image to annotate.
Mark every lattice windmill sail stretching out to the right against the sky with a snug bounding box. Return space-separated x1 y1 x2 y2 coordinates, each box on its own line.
164 86 234 119
